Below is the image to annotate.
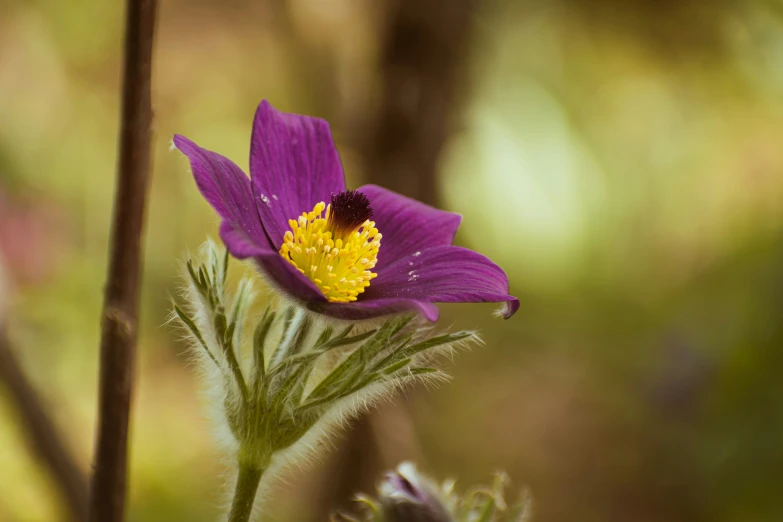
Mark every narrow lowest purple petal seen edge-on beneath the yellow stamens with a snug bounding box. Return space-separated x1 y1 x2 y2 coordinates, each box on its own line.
307 296 439 322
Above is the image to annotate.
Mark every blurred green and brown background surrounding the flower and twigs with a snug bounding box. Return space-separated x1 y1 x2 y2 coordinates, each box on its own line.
0 0 783 522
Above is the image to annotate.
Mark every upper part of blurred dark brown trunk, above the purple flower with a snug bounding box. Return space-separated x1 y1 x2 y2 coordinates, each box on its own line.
361 0 479 205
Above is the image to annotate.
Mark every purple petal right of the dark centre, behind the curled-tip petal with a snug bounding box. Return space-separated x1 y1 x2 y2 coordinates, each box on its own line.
358 185 462 274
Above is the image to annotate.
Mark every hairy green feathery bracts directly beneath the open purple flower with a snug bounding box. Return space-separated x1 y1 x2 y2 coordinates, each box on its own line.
174 242 477 516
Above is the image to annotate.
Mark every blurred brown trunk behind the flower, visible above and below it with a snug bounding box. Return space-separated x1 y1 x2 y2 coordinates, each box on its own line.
321 0 477 515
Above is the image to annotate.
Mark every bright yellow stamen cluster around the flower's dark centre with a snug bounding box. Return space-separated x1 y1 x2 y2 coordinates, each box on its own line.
280 202 382 303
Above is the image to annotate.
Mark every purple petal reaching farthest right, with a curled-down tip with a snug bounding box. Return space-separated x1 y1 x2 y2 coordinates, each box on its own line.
360 244 519 318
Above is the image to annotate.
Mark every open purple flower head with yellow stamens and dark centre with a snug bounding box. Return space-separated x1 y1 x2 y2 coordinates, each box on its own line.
174 101 519 321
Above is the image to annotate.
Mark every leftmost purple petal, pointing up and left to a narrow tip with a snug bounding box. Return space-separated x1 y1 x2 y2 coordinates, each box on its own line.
174 134 270 258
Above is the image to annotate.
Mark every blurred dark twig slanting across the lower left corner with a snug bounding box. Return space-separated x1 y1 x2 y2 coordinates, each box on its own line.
0 325 87 522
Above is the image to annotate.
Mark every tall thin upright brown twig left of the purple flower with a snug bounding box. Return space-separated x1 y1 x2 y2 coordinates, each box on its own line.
89 0 157 522
